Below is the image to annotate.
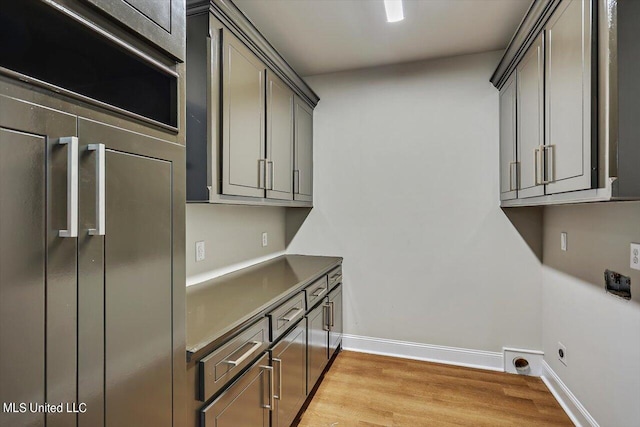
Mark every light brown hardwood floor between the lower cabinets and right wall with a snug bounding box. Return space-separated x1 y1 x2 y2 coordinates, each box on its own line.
298 351 573 427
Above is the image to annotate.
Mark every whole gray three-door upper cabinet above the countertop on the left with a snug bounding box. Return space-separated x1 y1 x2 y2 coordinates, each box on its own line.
186 6 319 207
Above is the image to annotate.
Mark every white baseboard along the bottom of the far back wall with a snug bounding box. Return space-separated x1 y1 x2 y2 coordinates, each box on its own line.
342 334 503 372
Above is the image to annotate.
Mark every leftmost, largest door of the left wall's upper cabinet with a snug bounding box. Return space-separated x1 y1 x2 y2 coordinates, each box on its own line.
222 30 266 197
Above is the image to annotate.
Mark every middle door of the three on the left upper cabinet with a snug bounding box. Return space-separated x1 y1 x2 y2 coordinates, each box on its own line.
267 72 293 200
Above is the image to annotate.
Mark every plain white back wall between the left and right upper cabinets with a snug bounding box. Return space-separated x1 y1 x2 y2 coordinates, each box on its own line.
287 52 541 351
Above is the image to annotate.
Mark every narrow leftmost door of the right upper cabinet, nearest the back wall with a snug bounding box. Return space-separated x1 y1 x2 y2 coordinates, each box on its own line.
500 73 518 200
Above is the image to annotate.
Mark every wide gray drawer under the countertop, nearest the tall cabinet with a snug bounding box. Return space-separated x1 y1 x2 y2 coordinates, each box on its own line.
198 317 269 402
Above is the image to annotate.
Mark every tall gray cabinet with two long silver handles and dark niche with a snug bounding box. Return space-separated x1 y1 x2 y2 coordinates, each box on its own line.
0 0 185 427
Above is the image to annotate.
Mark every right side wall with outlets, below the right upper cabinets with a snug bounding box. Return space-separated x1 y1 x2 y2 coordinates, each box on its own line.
542 202 640 427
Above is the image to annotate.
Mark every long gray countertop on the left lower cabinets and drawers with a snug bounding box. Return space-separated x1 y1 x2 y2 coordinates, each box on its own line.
187 255 342 356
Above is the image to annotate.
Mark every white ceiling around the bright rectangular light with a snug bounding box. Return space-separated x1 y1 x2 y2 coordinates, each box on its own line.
233 0 531 76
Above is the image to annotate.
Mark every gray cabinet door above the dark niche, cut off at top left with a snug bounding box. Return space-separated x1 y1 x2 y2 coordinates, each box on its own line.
80 0 186 61
